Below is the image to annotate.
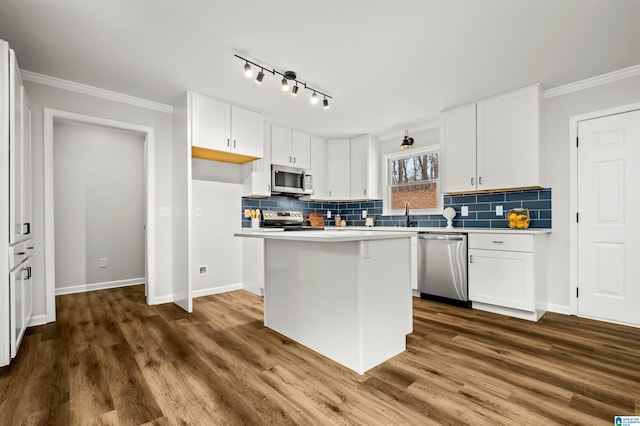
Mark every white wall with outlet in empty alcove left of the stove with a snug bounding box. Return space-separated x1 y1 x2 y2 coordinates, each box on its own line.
191 179 243 297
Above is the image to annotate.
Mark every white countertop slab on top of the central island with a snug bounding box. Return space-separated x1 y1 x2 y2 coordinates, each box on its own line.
234 227 415 243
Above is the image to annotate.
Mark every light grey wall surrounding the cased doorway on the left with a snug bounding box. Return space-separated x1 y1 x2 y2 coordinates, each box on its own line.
25 82 172 316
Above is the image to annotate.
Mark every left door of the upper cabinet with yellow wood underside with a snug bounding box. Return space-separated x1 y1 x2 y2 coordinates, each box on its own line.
191 93 231 151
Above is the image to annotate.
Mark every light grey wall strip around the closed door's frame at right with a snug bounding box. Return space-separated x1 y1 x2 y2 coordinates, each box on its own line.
540 77 640 313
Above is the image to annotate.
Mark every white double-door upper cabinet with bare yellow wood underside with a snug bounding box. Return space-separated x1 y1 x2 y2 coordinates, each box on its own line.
187 92 264 164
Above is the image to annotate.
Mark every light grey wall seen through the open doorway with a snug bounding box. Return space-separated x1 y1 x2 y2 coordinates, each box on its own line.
53 121 145 291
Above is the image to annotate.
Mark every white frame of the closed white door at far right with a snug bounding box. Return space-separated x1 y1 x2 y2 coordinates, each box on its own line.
569 103 640 315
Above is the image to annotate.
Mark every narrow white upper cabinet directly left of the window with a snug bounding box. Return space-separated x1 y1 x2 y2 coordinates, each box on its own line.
349 135 380 200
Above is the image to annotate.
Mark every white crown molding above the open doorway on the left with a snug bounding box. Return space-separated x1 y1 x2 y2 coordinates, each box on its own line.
20 70 173 114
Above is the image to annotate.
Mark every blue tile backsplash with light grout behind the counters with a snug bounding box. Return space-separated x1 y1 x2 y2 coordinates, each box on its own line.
241 188 551 228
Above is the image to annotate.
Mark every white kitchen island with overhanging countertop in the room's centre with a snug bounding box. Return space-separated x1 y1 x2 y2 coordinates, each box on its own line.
235 230 413 374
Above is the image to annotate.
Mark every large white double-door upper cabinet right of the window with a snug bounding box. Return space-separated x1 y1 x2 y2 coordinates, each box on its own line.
441 84 540 193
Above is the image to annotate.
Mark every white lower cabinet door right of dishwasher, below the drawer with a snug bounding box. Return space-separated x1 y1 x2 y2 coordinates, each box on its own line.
469 249 535 311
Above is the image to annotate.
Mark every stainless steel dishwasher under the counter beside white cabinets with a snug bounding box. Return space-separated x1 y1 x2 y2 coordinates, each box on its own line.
418 232 471 306
